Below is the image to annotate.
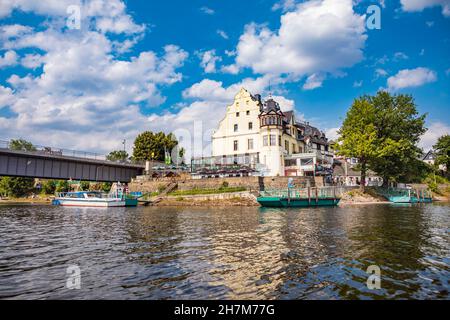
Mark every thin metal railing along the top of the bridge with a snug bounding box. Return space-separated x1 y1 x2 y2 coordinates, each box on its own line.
0 140 143 165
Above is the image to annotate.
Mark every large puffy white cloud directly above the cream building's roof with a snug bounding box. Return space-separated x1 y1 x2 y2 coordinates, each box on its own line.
232 0 367 82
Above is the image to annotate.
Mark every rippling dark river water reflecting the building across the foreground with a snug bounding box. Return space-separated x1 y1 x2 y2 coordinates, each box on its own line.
0 203 450 299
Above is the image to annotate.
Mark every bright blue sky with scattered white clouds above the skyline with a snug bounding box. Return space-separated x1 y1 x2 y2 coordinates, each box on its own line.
0 0 450 156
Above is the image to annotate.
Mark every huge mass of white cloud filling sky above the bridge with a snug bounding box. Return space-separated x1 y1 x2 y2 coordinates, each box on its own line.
0 0 188 152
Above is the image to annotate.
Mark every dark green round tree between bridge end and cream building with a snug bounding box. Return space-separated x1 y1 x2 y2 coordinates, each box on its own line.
133 131 178 161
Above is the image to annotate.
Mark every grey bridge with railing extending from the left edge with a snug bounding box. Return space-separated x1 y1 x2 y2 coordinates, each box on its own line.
0 141 145 182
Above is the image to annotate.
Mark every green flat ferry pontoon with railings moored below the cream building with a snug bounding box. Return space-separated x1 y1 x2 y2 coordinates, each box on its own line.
257 187 341 208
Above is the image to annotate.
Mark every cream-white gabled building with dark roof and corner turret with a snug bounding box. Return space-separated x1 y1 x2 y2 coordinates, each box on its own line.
193 88 333 176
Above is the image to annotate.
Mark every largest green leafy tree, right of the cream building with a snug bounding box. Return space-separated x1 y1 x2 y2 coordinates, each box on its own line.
338 91 429 191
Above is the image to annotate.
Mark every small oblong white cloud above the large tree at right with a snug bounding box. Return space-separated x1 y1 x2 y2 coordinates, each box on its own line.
387 68 437 91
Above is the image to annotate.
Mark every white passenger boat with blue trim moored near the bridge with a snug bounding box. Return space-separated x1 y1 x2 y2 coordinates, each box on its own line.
52 191 126 207
